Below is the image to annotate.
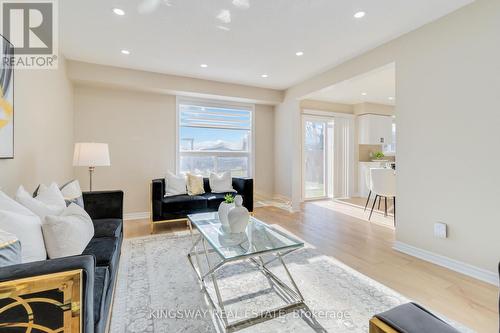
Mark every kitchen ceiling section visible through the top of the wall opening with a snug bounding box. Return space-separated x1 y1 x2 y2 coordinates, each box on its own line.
307 64 396 105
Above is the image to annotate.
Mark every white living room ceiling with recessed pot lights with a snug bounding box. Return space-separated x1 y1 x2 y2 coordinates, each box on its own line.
59 0 472 89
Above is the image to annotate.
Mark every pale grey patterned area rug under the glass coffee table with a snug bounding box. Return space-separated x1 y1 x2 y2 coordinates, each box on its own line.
111 233 472 333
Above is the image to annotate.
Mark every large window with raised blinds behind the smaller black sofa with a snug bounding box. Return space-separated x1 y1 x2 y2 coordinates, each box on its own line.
177 100 253 177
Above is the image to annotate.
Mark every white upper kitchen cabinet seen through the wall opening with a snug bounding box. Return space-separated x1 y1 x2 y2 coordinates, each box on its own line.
358 114 392 145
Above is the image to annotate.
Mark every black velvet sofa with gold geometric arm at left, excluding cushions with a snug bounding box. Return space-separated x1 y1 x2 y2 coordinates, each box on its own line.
0 191 123 333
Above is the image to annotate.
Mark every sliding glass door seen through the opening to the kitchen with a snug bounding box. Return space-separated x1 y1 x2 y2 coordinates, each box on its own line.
302 116 332 200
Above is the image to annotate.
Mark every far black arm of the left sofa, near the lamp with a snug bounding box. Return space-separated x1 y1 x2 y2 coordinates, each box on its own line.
83 191 123 220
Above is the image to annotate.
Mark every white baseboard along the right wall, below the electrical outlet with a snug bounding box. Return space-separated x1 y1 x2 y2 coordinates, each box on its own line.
393 241 499 286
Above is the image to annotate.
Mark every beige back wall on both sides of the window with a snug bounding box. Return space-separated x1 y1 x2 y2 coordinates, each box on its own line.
75 85 274 213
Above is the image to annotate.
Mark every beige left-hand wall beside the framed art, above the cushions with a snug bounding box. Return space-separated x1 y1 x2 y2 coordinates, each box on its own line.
0 58 73 195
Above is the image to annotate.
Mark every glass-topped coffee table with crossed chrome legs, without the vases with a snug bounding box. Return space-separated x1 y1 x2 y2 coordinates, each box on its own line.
188 212 307 332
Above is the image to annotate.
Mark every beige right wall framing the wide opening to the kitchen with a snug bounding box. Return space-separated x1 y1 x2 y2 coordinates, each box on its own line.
275 0 500 276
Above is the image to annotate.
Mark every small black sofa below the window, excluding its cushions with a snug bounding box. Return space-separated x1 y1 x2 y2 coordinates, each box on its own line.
151 178 253 223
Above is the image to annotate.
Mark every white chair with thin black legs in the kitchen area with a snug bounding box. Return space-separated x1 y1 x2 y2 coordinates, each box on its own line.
368 168 396 224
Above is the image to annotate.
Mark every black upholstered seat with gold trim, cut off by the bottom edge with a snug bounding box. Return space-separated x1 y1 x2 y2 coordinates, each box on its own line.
370 303 459 333
